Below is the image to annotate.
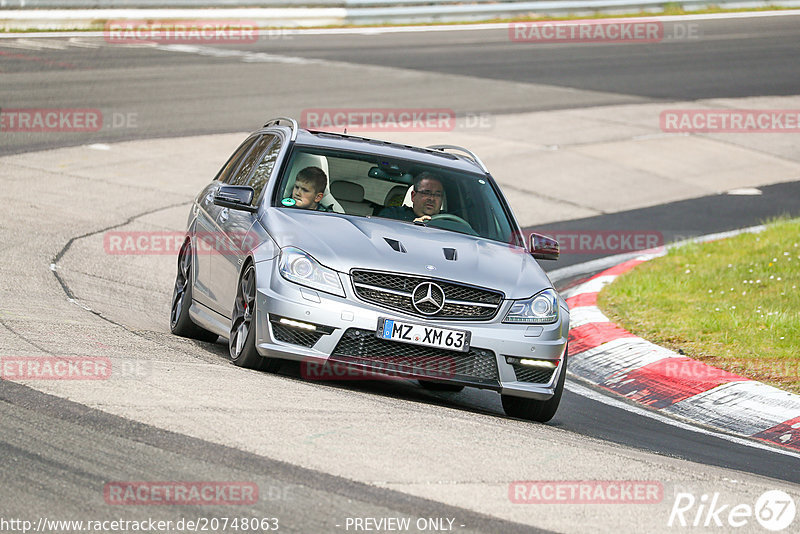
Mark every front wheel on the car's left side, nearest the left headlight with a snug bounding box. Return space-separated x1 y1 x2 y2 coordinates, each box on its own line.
228 263 283 373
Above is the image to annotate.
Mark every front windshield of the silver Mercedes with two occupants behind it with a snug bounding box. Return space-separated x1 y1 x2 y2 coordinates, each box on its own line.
274 147 518 244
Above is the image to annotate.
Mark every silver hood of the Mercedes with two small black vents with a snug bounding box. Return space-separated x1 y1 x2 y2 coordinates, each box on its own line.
261 208 553 299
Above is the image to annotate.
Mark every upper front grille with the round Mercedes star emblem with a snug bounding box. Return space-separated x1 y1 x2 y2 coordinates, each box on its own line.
350 270 503 321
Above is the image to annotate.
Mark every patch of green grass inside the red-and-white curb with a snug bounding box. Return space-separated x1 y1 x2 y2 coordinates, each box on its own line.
598 219 800 393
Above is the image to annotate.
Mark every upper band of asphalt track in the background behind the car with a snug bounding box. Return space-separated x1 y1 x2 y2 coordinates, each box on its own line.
0 16 800 155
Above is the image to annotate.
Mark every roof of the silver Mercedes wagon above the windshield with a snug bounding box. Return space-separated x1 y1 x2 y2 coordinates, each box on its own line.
265 126 487 174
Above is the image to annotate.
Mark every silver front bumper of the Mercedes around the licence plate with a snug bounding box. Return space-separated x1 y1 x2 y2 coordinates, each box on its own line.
256 261 569 400
